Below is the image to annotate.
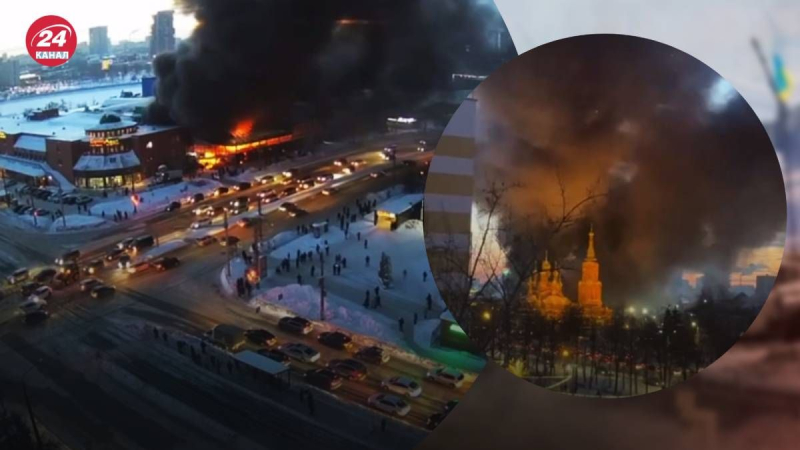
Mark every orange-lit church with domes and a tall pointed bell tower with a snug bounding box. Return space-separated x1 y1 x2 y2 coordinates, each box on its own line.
528 228 612 322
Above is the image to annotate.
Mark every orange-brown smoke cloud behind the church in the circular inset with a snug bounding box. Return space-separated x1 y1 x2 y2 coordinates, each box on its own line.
477 35 786 304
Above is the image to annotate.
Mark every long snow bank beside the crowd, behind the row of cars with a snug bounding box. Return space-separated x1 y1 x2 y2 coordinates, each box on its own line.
250 284 404 345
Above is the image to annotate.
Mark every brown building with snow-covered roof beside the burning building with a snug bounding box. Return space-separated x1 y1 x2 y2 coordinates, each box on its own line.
0 110 191 189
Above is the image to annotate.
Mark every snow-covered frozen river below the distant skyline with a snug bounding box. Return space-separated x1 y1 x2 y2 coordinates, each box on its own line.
0 82 142 116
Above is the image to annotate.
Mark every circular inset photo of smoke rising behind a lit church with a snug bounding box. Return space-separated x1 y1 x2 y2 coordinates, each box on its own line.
424 35 787 398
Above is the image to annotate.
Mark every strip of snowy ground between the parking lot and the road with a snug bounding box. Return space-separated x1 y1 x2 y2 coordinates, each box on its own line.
90 179 220 218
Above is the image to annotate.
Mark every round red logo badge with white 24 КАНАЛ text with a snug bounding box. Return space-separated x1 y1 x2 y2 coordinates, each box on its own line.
25 16 78 67
